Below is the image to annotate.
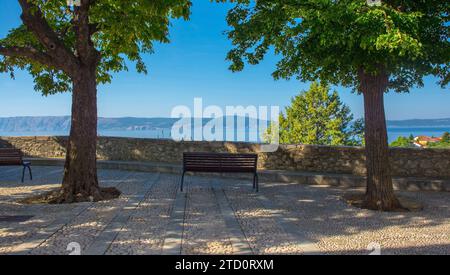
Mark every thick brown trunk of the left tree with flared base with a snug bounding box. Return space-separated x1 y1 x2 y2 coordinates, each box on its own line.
58 66 120 203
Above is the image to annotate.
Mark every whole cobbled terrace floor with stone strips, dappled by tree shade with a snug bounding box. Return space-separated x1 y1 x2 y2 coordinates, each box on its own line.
0 167 450 254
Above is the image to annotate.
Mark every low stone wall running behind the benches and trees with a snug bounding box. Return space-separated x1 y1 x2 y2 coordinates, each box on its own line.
0 137 450 179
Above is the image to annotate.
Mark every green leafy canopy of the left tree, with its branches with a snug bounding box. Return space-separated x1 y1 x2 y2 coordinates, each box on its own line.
0 0 191 95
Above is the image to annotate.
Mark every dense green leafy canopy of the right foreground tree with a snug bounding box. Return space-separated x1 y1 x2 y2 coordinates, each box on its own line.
224 0 450 92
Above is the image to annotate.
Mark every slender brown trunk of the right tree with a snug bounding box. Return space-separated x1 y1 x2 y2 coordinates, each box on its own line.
359 67 401 211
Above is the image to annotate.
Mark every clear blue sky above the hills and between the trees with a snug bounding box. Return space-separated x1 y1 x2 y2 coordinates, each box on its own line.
0 0 450 119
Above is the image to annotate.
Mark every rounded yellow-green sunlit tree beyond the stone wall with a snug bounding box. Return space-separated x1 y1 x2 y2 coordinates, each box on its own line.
272 82 364 145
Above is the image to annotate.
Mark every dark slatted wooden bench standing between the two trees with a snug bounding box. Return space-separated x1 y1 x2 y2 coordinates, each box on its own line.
181 153 259 192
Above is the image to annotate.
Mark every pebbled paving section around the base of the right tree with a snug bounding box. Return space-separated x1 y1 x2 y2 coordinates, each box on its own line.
265 184 450 254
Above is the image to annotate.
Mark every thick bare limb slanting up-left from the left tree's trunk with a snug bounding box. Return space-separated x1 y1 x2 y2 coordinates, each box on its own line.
18 0 78 72
